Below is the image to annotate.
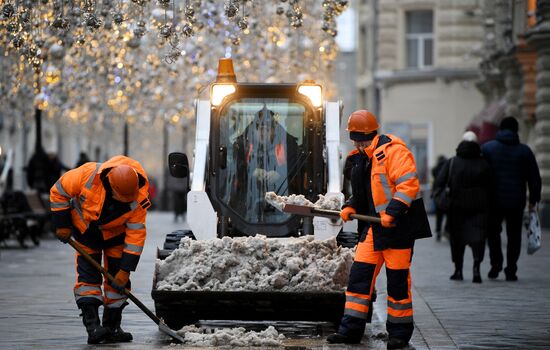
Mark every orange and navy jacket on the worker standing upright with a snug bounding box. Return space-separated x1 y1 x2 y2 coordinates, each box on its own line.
347 134 426 250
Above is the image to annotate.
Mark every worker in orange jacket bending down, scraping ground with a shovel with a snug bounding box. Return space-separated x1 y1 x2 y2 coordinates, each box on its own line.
50 156 151 344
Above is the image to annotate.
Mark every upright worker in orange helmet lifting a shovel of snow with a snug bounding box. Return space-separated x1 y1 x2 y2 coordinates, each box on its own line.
327 110 431 349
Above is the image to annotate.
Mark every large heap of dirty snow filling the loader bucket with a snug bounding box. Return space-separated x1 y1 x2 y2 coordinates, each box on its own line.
157 235 353 292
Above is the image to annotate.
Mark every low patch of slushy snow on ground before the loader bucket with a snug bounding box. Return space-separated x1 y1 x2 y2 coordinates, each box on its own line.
178 326 285 347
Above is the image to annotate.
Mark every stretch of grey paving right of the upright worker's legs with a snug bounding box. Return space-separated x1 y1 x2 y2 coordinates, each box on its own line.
412 215 550 349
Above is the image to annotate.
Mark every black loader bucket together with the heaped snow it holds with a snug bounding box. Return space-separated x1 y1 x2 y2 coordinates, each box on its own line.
152 235 353 329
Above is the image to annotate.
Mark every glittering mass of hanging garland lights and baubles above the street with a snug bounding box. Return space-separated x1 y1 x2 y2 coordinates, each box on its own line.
0 0 347 130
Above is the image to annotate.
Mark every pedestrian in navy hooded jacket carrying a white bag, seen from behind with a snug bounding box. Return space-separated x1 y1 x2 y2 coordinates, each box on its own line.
481 117 541 281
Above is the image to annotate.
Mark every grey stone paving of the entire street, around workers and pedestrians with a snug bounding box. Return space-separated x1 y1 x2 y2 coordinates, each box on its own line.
0 212 550 350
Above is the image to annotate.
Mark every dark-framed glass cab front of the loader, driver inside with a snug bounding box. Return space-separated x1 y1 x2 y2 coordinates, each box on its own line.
208 84 326 237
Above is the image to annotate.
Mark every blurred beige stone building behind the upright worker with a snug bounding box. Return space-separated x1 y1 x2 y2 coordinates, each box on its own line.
357 0 484 188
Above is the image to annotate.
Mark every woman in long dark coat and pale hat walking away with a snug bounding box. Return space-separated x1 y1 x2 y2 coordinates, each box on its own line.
435 133 494 283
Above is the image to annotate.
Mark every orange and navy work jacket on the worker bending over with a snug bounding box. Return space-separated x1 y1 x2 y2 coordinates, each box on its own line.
50 156 151 271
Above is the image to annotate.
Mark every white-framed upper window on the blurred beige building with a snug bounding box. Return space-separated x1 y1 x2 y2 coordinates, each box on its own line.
405 10 433 69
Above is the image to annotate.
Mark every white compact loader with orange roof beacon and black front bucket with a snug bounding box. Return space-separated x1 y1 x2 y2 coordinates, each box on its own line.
152 59 362 328
